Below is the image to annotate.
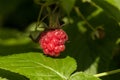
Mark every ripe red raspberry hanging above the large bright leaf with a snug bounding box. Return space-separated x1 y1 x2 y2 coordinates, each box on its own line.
39 29 68 57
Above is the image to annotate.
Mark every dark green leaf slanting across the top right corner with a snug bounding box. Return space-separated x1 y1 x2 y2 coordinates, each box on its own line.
92 0 120 23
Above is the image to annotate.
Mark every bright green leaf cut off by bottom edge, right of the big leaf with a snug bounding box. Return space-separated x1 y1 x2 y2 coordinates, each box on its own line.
70 72 101 80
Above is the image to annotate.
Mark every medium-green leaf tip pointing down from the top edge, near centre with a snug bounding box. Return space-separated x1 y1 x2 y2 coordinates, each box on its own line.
60 0 76 14
